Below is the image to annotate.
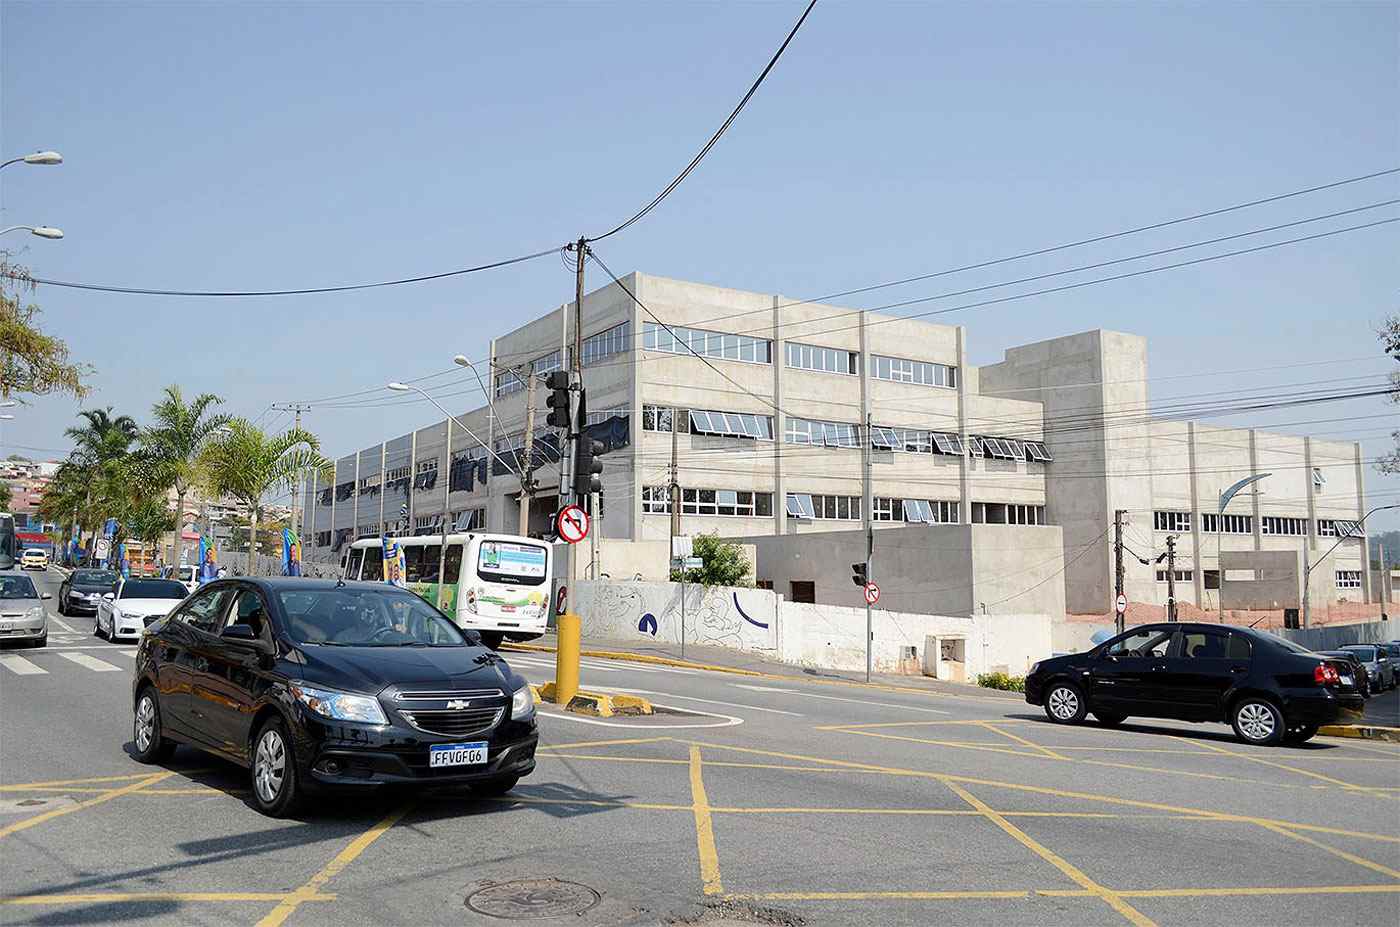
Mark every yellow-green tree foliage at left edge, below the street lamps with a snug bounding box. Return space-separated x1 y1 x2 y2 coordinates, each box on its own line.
0 252 92 399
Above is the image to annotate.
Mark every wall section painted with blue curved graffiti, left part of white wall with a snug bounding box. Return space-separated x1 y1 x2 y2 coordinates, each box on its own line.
577 581 777 650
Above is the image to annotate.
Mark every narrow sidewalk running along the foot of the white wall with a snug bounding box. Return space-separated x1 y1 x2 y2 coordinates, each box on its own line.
501 630 1025 703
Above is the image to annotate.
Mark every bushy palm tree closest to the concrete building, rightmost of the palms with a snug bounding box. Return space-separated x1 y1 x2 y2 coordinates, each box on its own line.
200 419 333 576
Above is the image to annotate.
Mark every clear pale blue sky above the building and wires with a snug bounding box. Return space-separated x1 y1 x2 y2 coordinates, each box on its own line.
0 0 1400 528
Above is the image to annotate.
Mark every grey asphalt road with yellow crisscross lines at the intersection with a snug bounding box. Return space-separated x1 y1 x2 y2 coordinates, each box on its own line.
0 576 1400 927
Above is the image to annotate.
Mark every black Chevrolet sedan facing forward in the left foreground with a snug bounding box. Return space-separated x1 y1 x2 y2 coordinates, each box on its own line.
132 577 539 816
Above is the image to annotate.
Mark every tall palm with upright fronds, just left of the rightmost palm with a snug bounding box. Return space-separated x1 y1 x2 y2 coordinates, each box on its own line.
136 385 230 563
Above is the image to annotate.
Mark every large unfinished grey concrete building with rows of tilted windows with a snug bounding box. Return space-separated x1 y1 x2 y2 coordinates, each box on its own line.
302 273 1369 613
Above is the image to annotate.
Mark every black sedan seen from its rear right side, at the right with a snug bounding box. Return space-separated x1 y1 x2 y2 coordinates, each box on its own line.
1026 623 1365 744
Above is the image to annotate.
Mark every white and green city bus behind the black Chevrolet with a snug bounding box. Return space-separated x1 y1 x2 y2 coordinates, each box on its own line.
342 534 553 648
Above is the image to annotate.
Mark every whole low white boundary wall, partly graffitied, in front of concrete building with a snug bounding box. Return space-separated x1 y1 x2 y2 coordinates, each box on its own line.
570 581 1050 681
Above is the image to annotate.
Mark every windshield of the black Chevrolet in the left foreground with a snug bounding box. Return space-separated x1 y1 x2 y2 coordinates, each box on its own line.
277 587 466 647
